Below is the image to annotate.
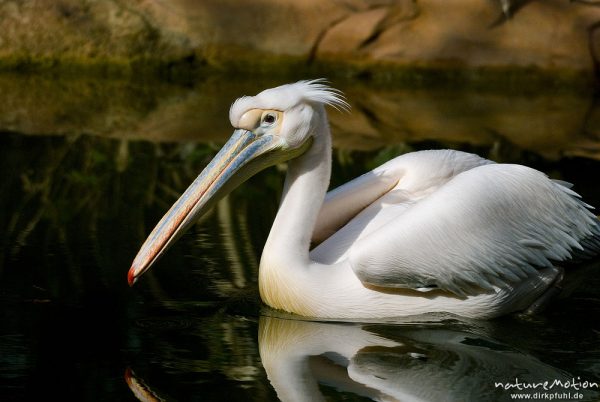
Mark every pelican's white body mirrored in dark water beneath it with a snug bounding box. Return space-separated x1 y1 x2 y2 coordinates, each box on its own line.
259 316 598 401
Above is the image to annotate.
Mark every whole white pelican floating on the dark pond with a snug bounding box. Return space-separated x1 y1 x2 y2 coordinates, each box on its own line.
128 80 600 319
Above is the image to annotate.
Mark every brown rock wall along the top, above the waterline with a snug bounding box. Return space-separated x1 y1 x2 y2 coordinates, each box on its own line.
0 0 600 76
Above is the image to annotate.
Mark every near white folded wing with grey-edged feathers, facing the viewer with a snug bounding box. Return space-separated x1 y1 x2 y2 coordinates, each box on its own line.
339 164 600 296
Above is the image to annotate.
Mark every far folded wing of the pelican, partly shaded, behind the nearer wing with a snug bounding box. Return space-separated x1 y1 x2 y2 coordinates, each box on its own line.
311 150 493 258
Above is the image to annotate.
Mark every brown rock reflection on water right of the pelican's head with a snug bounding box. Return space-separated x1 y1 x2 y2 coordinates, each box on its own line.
331 88 600 159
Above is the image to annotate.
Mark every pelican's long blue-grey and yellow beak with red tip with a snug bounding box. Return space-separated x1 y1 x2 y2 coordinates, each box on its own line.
127 129 310 286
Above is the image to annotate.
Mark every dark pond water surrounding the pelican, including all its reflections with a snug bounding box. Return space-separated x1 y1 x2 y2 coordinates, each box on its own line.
0 76 600 401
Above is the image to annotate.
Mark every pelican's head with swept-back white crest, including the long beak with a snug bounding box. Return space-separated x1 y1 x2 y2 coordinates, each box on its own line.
127 80 347 285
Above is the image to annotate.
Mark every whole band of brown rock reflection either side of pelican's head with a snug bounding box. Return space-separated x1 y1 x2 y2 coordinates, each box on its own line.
0 74 600 159
